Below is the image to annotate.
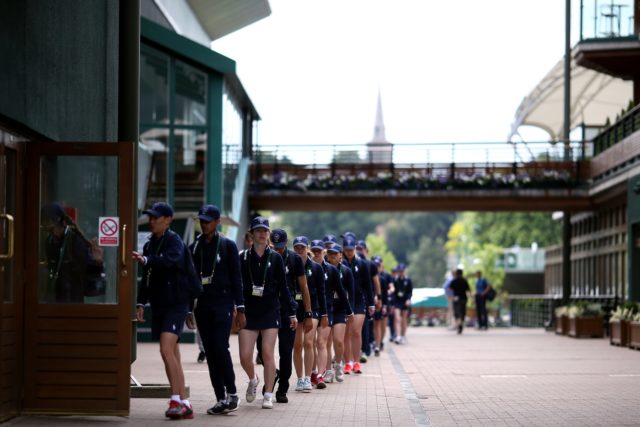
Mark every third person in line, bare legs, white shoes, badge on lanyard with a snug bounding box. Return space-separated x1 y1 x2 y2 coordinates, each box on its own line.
238 216 298 409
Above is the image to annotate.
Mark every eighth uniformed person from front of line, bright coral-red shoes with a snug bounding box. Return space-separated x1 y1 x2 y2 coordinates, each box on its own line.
342 233 375 375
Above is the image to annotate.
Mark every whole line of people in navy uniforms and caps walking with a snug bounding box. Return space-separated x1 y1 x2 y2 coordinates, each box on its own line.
133 202 413 419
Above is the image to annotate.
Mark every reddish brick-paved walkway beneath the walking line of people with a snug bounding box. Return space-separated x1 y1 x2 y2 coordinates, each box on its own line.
7 328 640 427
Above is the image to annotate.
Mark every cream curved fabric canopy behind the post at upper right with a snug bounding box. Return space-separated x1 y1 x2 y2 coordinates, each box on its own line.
509 54 633 141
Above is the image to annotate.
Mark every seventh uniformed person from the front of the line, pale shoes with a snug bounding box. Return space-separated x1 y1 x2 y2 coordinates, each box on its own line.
327 244 355 382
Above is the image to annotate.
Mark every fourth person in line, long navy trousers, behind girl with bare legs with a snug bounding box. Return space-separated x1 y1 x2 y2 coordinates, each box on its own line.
258 228 313 403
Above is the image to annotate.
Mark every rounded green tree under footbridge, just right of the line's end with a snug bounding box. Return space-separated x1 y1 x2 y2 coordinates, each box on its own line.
407 236 447 288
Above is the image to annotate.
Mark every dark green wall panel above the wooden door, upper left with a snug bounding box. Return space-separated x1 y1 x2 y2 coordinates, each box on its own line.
0 0 118 141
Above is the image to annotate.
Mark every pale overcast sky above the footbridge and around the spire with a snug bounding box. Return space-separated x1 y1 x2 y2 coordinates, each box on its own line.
212 0 579 149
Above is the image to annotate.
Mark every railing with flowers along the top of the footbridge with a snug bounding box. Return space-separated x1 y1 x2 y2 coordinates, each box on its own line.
252 143 588 190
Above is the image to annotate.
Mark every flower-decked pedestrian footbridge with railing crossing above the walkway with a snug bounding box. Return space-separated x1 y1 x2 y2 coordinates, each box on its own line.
249 142 592 211
